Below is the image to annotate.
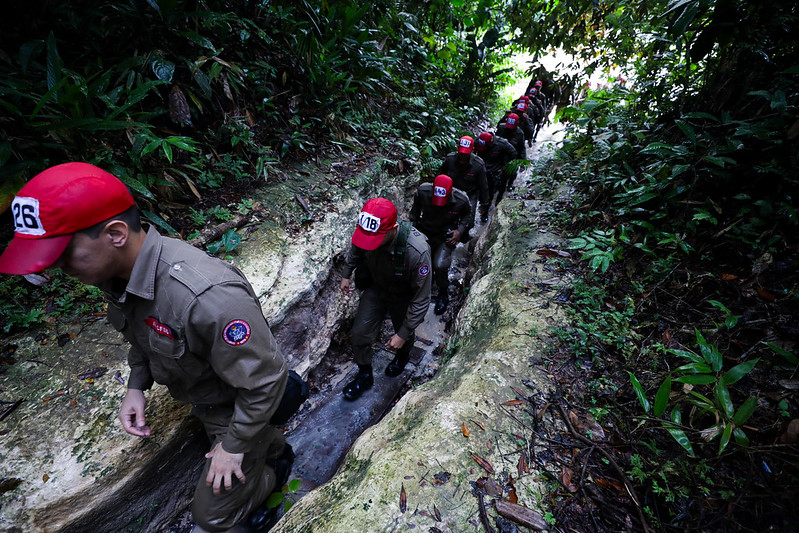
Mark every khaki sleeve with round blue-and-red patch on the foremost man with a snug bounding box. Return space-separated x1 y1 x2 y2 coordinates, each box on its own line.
186 282 288 453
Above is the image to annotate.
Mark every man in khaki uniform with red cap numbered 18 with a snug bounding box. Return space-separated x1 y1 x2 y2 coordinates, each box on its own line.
340 198 431 401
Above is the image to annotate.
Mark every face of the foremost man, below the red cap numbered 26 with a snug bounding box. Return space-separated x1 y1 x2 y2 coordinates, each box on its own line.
52 232 115 285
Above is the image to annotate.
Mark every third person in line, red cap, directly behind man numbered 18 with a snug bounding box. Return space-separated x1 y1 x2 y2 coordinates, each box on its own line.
408 174 474 315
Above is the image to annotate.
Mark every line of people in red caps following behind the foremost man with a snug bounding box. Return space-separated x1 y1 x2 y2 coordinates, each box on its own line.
340 81 547 401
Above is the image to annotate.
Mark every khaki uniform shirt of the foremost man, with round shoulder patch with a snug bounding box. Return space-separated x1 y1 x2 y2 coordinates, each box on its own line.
100 228 288 453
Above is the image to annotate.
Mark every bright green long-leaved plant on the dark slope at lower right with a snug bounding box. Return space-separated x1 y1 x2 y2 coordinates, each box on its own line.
629 330 759 456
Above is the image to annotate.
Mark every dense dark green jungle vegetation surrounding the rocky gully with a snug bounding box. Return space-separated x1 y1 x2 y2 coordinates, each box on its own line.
0 0 799 531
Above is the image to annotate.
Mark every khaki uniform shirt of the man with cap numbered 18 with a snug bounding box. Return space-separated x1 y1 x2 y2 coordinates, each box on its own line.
341 228 432 340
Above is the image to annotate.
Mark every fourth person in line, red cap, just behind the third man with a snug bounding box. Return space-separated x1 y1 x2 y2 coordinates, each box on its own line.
438 135 490 228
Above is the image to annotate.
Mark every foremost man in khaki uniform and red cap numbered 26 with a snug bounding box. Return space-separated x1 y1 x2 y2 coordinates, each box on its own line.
0 163 293 532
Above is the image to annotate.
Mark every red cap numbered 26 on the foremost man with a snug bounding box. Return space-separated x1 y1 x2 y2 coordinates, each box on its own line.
0 163 134 274
